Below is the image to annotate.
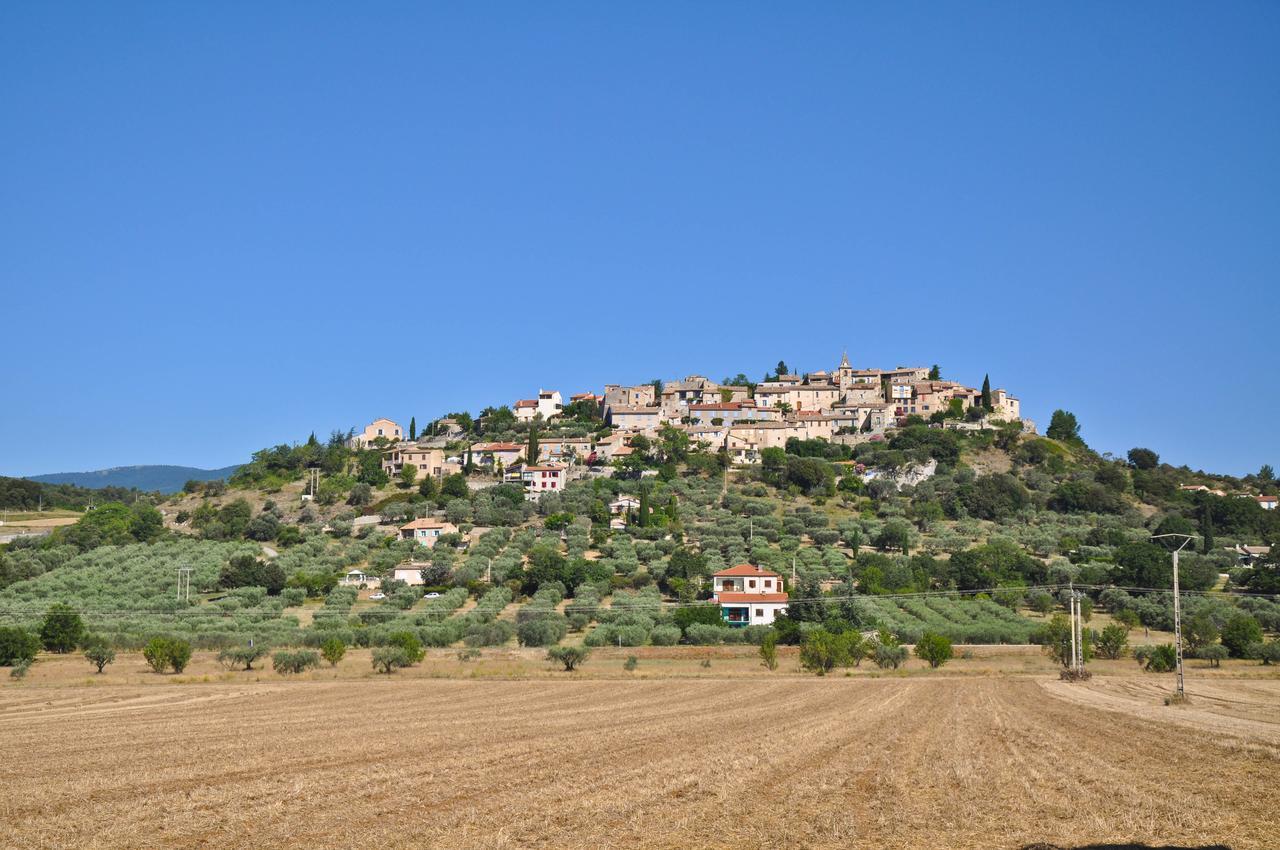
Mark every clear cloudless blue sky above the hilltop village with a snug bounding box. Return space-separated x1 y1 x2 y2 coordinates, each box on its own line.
0 3 1280 475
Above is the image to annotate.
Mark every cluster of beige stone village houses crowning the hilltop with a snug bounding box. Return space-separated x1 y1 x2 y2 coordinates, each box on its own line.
358 355 1036 498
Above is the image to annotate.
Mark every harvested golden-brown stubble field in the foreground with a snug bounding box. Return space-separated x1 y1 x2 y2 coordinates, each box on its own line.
0 676 1280 850
